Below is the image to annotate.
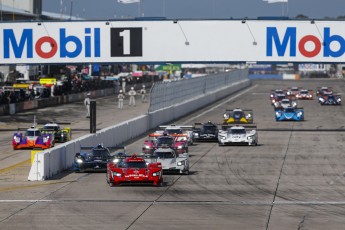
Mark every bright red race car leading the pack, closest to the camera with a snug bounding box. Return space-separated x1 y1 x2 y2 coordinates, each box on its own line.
107 154 163 187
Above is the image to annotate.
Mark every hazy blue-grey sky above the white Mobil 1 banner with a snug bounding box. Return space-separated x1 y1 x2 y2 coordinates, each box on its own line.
42 0 345 20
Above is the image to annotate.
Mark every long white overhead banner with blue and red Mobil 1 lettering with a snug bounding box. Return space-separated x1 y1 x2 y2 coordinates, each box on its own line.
0 20 345 64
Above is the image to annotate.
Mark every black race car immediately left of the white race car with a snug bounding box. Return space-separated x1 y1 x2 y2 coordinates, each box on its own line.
193 121 218 141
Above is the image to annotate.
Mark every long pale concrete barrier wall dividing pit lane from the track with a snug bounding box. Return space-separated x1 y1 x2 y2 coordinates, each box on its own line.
28 73 251 181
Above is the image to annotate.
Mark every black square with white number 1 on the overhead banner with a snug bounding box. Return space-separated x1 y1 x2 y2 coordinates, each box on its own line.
110 28 143 57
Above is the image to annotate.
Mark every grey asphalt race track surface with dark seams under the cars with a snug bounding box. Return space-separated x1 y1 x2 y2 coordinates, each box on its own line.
0 80 345 230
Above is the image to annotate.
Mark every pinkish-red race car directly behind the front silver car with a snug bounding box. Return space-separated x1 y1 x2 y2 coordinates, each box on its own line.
142 131 188 154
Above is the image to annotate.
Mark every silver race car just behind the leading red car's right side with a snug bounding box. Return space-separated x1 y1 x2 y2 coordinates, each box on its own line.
151 148 189 175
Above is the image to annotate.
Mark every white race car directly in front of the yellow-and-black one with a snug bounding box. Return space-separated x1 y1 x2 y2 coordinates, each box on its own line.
218 124 258 146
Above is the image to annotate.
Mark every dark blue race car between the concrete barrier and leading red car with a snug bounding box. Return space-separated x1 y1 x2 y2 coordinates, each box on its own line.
73 144 126 172
